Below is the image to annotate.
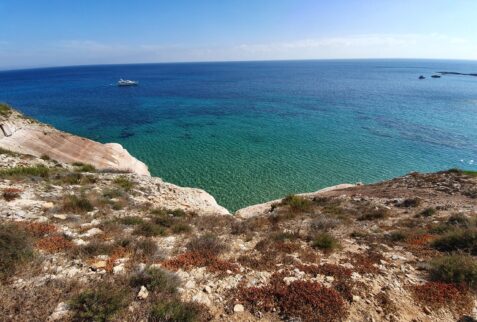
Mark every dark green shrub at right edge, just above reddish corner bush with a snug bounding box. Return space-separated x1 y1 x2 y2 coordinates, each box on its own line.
429 254 477 289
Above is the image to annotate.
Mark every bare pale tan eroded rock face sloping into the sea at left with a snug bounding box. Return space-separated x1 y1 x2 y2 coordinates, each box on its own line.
0 111 150 176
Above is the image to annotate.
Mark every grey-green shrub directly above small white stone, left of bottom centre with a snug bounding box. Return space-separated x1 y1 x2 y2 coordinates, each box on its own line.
130 268 180 294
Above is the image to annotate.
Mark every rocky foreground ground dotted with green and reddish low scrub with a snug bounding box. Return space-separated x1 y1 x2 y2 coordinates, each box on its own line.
0 150 477 321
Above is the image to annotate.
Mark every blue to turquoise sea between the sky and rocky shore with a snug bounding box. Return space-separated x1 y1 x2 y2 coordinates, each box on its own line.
0 60 477 210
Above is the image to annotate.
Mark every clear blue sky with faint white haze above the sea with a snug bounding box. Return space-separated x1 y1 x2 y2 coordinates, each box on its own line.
0 0 477 70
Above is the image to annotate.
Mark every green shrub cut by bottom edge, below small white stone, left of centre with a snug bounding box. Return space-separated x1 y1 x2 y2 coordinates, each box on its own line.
149 299 203 322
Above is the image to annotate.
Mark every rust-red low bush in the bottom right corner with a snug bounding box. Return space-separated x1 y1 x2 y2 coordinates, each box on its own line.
413 282 473 313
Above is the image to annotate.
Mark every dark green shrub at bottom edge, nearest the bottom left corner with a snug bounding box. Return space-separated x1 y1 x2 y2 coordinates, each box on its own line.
69 285 126 322
